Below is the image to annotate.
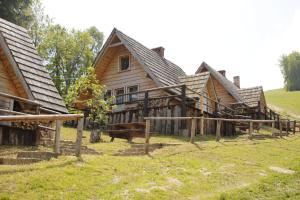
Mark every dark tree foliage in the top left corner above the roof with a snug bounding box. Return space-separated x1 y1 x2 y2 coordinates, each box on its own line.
0 0 34 28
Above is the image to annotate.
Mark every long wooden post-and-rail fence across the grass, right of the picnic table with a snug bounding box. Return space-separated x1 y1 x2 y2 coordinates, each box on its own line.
144 117 300 153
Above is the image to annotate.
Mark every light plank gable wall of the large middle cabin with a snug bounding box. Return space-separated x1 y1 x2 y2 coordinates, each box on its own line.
97 45 163 98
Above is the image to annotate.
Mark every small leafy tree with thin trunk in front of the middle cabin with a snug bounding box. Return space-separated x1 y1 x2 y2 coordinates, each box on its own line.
66 67 113 142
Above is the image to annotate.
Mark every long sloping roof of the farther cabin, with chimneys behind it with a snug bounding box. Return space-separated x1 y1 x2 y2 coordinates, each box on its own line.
196 62 243 102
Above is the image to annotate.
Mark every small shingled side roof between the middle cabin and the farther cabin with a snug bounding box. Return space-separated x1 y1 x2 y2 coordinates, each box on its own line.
179 72 210 97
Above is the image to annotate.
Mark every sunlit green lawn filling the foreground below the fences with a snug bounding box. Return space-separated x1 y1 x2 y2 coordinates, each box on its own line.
0 128 300 200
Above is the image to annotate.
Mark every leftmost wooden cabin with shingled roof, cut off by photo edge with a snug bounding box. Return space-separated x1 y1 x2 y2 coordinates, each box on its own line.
0 18 68 145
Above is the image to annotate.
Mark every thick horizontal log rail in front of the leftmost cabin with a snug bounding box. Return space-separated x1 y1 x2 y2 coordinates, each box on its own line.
0 114 83 122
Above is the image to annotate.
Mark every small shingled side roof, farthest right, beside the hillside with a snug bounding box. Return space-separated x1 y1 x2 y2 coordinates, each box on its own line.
238 86 263 107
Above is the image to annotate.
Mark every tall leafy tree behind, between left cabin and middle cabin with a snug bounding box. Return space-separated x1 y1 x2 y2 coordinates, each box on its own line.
38 25 103 97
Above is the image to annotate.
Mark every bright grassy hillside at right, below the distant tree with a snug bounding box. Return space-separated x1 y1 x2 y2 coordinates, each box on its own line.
265 89 300 119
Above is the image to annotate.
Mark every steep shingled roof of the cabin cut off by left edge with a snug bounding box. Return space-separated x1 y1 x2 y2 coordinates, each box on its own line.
0 18 68 113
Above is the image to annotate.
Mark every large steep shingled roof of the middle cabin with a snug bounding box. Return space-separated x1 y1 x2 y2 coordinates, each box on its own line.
94 28 185 87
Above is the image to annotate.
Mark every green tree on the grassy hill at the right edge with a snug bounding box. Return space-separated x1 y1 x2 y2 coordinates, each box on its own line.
280 51 300 91
